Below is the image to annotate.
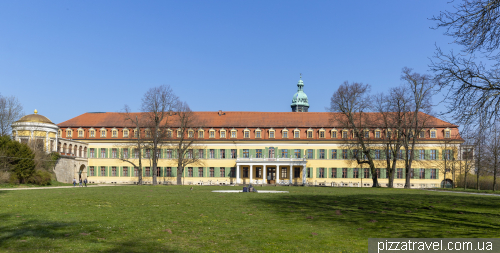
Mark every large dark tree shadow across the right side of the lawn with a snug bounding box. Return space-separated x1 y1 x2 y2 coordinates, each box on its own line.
249 189 500 238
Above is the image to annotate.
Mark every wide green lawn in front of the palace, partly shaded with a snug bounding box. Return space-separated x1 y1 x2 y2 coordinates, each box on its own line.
0 186 500 252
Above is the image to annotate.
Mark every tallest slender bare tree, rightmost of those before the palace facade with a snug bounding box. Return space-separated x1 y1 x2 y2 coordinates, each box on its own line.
398 67 435 188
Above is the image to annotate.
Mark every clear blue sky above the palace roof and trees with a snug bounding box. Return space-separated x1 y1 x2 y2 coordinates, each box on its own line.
0 0 458 123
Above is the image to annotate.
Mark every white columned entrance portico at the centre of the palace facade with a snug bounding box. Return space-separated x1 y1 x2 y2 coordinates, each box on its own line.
236 158 307 185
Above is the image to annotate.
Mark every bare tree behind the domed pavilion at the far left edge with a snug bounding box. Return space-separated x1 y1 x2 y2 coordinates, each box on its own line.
0 94 24 136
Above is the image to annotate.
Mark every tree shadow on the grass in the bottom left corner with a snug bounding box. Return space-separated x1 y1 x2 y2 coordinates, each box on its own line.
0 214 177 253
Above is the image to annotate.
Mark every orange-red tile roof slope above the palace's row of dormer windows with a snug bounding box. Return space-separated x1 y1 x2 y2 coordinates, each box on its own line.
57 112 458 128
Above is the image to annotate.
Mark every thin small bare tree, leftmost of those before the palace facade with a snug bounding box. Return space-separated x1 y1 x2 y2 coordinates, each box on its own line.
119 105 146 185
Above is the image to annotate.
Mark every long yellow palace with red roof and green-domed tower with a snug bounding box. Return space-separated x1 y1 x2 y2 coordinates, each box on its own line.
13 80 463 188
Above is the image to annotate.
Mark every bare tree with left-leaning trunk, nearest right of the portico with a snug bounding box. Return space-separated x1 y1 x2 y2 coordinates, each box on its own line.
330 81 379 187
